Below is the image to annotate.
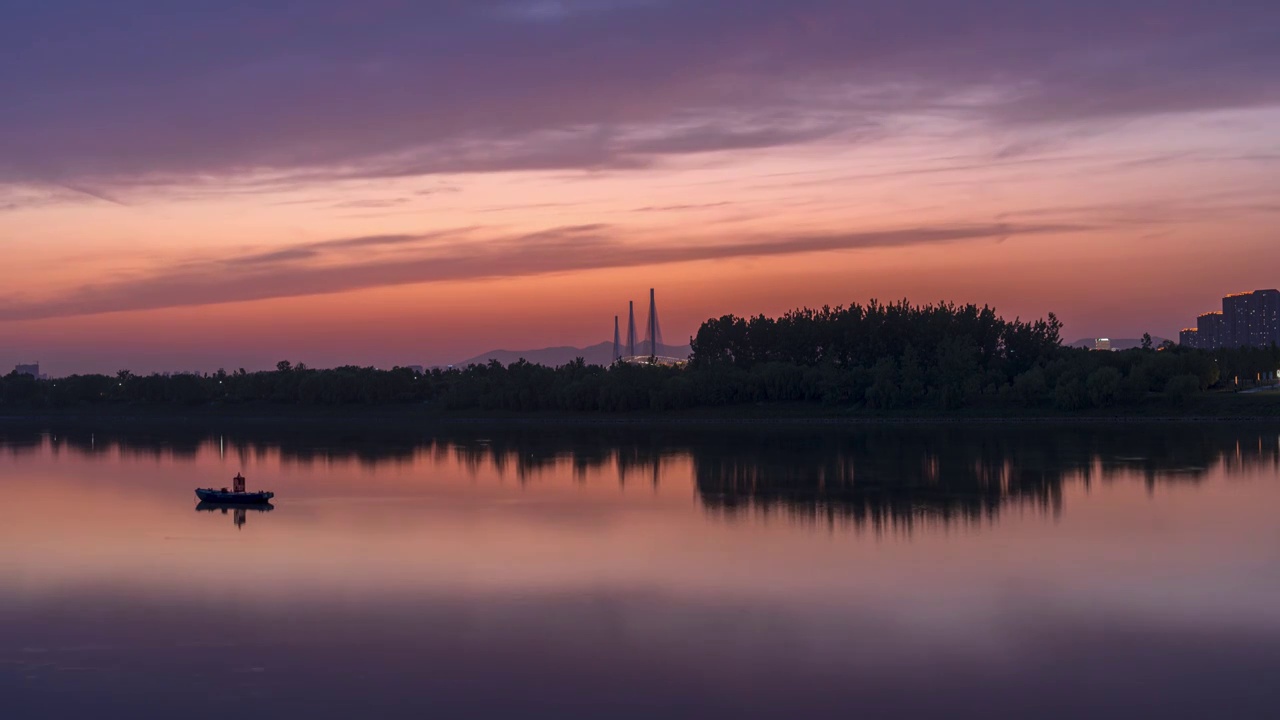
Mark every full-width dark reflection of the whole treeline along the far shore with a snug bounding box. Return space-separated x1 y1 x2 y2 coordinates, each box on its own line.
0 424 1280 530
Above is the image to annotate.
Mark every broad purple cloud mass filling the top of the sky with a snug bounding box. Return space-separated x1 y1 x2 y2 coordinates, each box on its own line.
0 0 1280 184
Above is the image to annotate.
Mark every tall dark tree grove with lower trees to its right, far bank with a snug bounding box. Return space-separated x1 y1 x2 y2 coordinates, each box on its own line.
692 300 1280 410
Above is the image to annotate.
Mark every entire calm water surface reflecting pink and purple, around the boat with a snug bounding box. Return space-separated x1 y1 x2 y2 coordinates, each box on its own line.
0 425 1280 720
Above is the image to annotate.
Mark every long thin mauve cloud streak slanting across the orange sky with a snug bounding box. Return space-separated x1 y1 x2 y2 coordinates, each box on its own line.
0 223 1087 322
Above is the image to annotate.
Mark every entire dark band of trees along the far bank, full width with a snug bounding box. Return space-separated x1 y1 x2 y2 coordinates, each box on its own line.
0 301 1280 413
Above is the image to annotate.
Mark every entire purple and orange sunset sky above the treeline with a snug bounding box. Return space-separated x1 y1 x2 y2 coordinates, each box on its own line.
0 0 1280 374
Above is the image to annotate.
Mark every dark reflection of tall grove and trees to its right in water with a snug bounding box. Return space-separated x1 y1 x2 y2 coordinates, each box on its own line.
692 427 1280 529
